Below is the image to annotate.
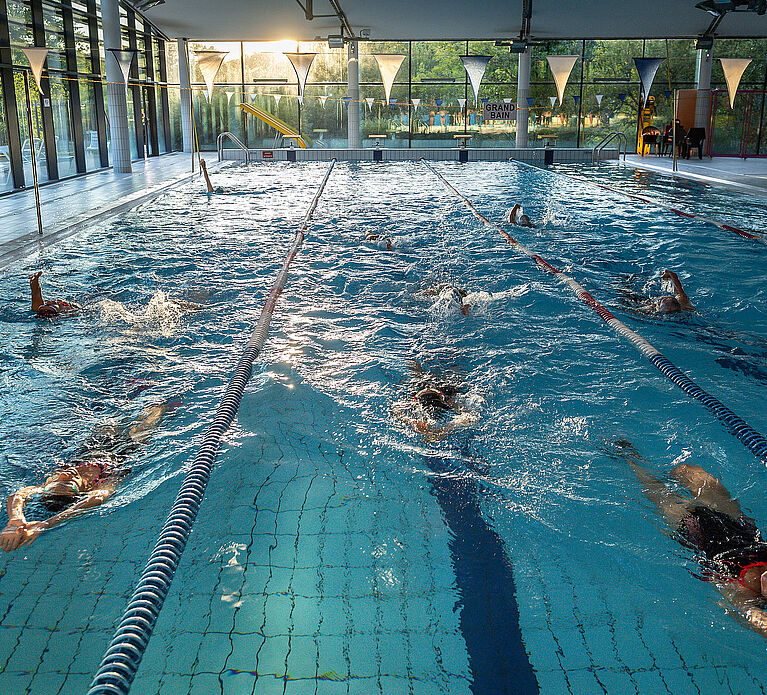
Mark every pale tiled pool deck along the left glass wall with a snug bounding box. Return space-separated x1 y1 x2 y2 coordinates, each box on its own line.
0 152 216 268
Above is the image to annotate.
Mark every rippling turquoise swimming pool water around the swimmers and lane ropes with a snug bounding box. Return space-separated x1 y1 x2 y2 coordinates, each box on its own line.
0 163 767 695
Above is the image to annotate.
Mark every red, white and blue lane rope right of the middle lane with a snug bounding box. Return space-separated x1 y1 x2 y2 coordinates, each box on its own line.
421 159 767 458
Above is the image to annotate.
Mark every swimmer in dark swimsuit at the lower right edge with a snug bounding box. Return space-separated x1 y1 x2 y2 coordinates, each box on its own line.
608 439 767 637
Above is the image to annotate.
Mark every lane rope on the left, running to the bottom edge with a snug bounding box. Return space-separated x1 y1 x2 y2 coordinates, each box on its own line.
88 159 336 695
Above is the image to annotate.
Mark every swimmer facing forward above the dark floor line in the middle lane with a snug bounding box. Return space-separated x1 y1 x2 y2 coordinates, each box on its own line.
393 361 477 441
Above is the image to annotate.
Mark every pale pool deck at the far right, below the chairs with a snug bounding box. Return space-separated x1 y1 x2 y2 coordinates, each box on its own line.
620 155 767 195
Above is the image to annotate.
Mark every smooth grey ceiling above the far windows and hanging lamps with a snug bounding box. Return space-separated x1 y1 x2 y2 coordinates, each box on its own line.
144 0 767 41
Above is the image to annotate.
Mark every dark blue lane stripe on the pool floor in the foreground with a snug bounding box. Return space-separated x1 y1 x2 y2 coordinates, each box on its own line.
422 455 539 695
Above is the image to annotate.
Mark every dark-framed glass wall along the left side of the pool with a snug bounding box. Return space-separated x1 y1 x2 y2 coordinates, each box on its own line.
0 0 172 191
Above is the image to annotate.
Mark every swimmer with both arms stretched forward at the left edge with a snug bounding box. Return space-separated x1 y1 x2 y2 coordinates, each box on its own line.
0 402 178 552
